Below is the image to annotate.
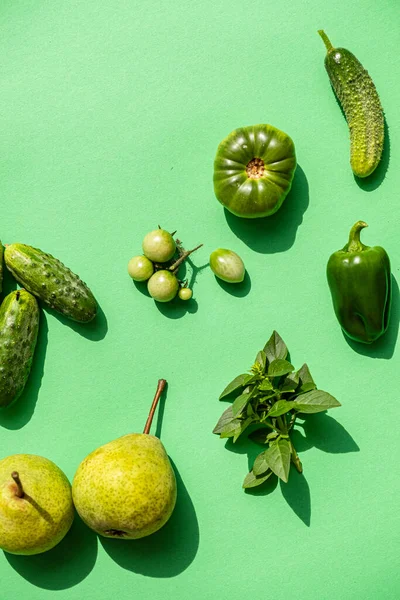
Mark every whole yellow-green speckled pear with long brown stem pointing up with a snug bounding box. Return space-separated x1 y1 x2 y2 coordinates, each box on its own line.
72 379 176 539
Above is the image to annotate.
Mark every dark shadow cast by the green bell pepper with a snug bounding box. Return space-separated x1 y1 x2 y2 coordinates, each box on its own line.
343 273 400 360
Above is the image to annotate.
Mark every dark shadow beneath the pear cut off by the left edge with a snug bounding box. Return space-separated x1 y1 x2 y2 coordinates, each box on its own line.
4 515 97 590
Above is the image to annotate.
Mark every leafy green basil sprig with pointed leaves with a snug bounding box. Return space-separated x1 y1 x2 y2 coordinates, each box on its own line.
213 331 340 488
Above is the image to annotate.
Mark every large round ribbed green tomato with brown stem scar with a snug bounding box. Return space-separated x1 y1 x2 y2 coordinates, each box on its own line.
214 125 296 219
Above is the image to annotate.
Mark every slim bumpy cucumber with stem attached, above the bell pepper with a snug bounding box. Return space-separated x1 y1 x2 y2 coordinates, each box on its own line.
318 30 384 177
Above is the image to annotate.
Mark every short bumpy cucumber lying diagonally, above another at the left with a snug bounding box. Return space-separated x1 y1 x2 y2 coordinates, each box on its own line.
4 244 97 323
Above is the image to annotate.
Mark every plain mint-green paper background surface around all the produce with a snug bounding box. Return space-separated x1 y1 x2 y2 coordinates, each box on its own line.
0 0 400 600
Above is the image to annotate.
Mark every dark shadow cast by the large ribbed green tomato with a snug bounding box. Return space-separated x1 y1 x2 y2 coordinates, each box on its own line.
224 165 309 254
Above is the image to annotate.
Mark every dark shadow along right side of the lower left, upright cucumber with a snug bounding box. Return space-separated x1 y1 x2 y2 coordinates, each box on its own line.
0 311 49 429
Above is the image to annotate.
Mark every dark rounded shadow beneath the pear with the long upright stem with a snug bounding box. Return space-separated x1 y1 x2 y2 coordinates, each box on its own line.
99 461 200 578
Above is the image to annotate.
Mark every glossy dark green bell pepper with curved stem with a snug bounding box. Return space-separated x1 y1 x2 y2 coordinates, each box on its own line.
327 221 391 344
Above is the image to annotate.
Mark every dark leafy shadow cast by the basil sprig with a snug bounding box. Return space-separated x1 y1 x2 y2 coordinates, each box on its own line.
225 412 360 527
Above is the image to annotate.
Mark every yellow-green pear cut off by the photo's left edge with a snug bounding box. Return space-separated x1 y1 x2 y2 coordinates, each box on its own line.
0 454 74 554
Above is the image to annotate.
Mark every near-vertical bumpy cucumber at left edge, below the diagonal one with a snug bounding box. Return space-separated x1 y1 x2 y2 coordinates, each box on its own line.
0 290 39 408
